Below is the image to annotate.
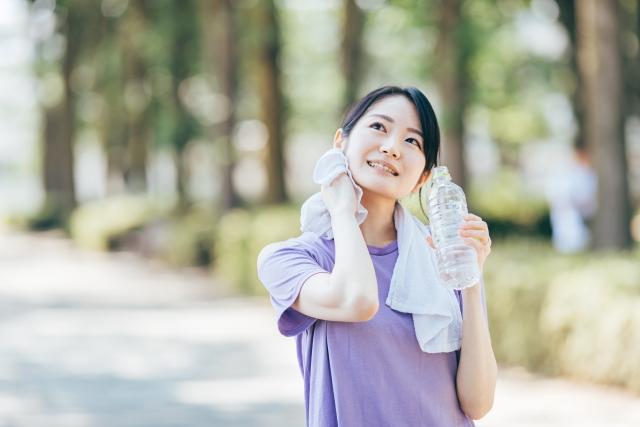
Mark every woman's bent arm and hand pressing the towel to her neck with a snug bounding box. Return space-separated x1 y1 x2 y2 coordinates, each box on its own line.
292 174 379 322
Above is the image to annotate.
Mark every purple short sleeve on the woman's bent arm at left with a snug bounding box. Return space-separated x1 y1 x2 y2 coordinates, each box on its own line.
258 242 328 337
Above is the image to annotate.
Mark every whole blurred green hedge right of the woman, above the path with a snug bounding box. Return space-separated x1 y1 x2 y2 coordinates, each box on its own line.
484 239 640 392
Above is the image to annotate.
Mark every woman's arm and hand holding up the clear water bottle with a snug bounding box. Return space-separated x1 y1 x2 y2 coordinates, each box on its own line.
427 214 498 420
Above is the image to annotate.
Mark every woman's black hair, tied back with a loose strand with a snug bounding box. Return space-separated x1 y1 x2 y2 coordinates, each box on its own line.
341 86 440 217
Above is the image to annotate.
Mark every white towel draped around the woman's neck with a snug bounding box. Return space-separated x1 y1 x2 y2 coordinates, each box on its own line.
300 149 462 353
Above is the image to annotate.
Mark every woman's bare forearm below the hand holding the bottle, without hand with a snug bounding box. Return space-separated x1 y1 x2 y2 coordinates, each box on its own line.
456 284 498 419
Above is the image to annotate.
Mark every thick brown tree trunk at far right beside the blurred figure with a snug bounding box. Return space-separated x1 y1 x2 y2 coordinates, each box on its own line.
575 0 631 249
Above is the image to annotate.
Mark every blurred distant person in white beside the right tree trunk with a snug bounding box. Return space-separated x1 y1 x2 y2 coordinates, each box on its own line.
545 148 597 253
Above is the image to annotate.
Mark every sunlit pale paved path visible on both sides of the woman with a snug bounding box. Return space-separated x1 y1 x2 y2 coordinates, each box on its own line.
0 232 640 427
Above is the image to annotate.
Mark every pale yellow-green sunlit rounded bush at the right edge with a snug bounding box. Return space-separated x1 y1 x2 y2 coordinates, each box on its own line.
540 256 640 392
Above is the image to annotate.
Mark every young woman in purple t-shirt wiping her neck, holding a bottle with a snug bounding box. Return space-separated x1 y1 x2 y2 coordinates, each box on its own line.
258 87 497 427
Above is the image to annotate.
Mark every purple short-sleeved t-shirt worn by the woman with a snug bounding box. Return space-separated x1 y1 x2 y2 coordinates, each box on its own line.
258 233 474 427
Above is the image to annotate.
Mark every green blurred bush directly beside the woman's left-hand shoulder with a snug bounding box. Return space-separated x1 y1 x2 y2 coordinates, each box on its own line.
214 205 300 295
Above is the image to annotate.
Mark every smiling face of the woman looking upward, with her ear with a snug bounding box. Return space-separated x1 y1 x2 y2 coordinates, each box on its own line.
334 96 428 200
